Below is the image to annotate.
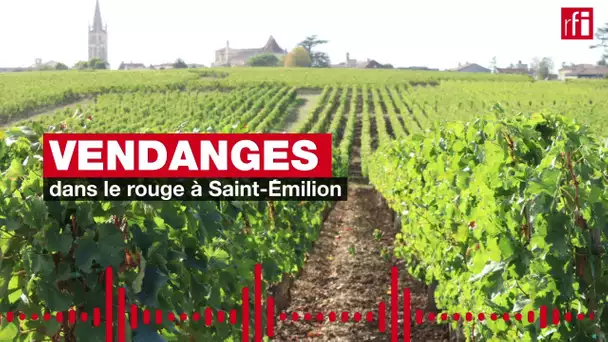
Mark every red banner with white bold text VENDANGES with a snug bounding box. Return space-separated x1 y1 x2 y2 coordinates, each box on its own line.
43 133 332 178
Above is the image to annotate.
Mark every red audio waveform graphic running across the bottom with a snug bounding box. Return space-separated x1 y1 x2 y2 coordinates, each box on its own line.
5 264 594 342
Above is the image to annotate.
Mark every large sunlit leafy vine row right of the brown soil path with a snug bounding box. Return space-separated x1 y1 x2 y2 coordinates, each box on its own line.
367 110 608 341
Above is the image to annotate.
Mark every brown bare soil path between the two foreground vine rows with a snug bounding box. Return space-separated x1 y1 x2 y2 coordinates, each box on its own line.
274 186 448 342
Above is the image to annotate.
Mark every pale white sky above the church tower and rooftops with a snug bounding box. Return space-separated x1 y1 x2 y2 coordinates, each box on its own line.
0 0 608 70
